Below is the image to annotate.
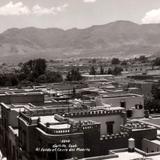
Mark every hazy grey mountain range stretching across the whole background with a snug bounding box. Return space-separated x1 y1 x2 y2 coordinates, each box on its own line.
0 21 160 62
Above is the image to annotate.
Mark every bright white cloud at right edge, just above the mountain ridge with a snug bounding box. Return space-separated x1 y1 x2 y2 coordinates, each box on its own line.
142 8 160 24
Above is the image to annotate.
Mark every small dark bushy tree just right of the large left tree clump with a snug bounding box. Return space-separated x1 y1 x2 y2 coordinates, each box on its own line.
66 68 82 81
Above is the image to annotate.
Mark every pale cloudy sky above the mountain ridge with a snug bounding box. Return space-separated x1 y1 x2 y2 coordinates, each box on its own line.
0 0 160 32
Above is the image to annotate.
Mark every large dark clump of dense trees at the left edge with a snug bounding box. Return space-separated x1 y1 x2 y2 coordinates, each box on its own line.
0 59 63 86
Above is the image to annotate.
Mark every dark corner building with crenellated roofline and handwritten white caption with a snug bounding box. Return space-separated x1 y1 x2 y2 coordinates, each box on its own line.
18 108 127 160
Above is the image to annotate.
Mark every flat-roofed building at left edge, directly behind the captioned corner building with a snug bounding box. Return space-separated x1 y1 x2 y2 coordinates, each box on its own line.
0 98 87 159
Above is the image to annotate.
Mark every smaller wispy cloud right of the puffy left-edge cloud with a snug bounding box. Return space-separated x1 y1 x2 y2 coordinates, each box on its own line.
32 4 68 16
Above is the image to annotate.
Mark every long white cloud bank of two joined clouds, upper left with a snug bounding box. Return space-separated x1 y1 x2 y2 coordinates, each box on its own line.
0 1 68 16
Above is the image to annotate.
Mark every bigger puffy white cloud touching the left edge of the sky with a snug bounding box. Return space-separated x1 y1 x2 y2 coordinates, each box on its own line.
0 1 30 16
